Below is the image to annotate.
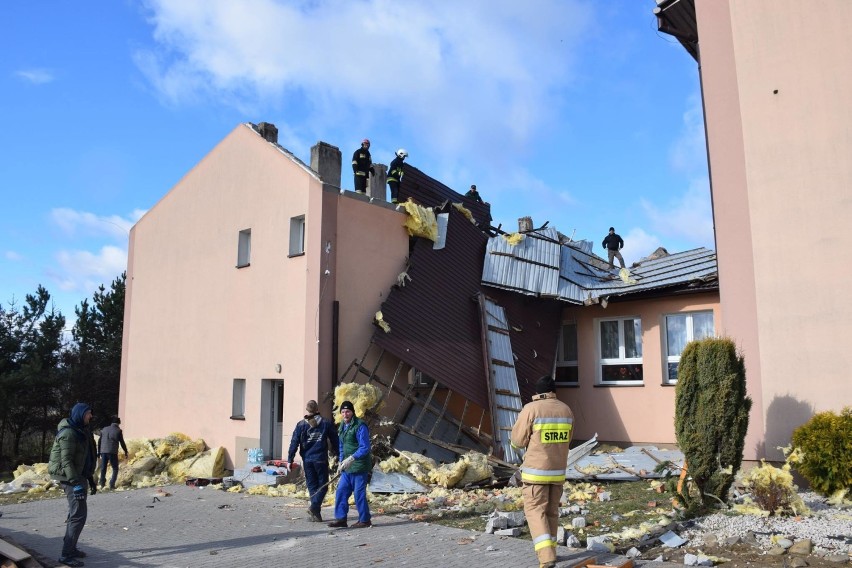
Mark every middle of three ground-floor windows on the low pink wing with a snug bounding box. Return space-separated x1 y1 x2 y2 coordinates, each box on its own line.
595 317 642 385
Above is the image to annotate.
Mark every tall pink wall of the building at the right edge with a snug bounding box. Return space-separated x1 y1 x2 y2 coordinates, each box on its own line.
696 0 852 459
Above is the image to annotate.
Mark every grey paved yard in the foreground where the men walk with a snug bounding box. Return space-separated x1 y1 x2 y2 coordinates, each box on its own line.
0 485 677 568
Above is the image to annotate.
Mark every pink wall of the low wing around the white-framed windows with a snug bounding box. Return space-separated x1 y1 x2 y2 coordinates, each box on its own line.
558 292 720 444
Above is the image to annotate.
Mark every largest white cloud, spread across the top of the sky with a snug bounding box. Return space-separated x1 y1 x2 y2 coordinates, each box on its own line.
135 0 594 156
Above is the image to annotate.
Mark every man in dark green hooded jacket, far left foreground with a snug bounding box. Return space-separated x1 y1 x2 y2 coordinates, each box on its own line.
48 402 97 568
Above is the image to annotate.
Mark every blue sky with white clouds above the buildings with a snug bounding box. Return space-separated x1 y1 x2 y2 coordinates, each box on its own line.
0 0 714 326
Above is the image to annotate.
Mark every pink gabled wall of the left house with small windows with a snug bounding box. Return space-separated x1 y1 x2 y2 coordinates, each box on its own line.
119 125 408 467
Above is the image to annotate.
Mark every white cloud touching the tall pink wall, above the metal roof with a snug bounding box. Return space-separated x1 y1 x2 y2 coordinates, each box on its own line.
641 179 714 247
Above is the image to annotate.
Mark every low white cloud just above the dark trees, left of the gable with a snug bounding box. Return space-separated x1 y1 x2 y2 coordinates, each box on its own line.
49 246 127 294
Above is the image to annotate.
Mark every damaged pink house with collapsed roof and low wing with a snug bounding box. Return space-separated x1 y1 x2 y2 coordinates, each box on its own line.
120 123 719 468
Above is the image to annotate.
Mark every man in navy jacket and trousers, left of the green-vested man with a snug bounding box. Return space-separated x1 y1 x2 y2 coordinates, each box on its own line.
287 400 340 523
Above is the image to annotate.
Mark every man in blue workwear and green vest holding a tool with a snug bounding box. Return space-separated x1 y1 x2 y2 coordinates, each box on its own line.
328 400 373 529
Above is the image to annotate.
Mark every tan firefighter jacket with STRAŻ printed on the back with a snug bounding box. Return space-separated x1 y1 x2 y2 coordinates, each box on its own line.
512 392 574 483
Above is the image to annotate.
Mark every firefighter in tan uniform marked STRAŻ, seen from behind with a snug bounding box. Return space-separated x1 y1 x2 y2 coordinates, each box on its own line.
511 376 574 568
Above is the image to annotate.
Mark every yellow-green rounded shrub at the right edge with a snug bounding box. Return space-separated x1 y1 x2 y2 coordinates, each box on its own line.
789 407 852 495
